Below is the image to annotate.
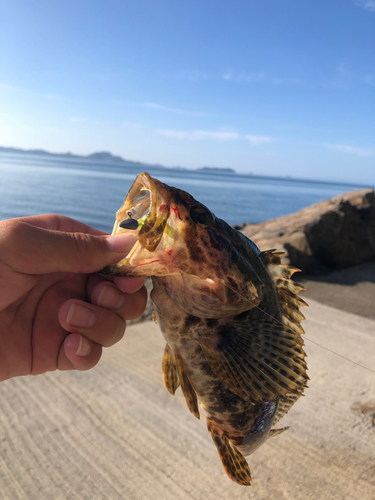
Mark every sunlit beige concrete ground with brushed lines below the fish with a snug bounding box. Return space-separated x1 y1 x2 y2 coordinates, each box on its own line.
0 300 375 500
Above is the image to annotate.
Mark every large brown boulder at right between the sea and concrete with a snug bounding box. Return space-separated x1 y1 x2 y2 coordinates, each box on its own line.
236 189 375 275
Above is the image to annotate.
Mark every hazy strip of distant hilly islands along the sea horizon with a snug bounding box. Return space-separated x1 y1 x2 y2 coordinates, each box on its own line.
0 146 236 174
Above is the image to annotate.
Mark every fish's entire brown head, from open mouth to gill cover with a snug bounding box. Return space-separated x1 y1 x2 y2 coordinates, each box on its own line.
103 173 264 318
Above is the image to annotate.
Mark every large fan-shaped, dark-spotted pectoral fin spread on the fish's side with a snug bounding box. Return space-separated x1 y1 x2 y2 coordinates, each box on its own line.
199 320 308 402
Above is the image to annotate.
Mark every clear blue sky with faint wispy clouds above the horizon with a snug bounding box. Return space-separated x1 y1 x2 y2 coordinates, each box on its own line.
0 0 375 185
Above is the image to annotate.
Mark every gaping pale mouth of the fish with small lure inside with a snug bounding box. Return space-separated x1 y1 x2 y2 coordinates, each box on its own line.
101 172 173 277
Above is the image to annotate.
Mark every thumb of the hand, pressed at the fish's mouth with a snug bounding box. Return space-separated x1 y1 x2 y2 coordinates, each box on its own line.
0 220 137 274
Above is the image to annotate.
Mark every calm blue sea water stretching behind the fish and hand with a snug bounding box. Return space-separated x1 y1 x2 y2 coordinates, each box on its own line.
0 153 372 232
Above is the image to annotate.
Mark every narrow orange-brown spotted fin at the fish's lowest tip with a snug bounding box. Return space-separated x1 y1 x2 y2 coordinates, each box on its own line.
207 419 251 486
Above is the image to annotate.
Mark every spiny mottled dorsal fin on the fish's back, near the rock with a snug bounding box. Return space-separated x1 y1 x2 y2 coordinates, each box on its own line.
259 249 308 334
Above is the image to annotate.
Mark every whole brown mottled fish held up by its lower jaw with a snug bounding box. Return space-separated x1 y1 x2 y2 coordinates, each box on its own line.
103 173 309 486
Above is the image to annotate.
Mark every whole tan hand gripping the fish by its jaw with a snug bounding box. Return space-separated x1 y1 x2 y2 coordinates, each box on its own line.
0 215 147 381
